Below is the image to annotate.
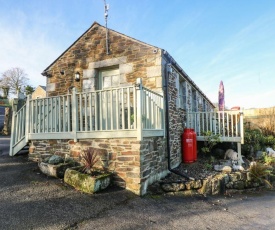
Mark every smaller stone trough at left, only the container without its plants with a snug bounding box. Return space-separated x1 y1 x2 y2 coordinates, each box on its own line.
38 162 73 178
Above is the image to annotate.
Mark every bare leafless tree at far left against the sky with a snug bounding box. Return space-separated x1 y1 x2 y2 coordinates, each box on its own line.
0 67 29 94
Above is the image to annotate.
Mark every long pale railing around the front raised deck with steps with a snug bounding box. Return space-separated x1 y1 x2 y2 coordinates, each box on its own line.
10 78 164 155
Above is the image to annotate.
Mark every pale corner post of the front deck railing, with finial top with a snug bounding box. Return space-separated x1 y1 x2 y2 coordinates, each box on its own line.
136 78 143 141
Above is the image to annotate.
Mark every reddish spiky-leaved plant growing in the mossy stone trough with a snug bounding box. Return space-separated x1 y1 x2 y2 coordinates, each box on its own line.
81 148 99 174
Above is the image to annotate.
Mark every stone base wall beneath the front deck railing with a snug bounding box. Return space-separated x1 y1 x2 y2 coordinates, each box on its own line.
29 138 167 195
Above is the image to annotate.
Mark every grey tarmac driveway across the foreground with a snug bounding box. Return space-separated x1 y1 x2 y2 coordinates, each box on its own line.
0 138 275 230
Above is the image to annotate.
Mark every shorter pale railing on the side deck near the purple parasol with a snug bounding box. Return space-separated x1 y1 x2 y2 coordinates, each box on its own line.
186 111 244 143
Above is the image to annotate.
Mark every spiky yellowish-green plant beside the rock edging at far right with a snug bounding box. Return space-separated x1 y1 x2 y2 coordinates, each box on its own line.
249 162 272 188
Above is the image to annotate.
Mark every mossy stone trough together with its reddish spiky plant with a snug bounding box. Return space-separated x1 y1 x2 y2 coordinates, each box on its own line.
64 148 111 194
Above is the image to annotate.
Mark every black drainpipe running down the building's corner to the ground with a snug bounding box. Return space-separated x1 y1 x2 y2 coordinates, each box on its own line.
164 63 195 180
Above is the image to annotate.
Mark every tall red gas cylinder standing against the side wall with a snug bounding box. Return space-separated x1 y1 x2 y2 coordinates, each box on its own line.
182 129 194 163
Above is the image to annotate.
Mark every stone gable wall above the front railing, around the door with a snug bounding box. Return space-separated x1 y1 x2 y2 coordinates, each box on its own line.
46 23 162 96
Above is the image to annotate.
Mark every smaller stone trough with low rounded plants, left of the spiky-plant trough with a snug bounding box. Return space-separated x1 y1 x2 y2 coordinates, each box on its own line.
38 155 79 178
